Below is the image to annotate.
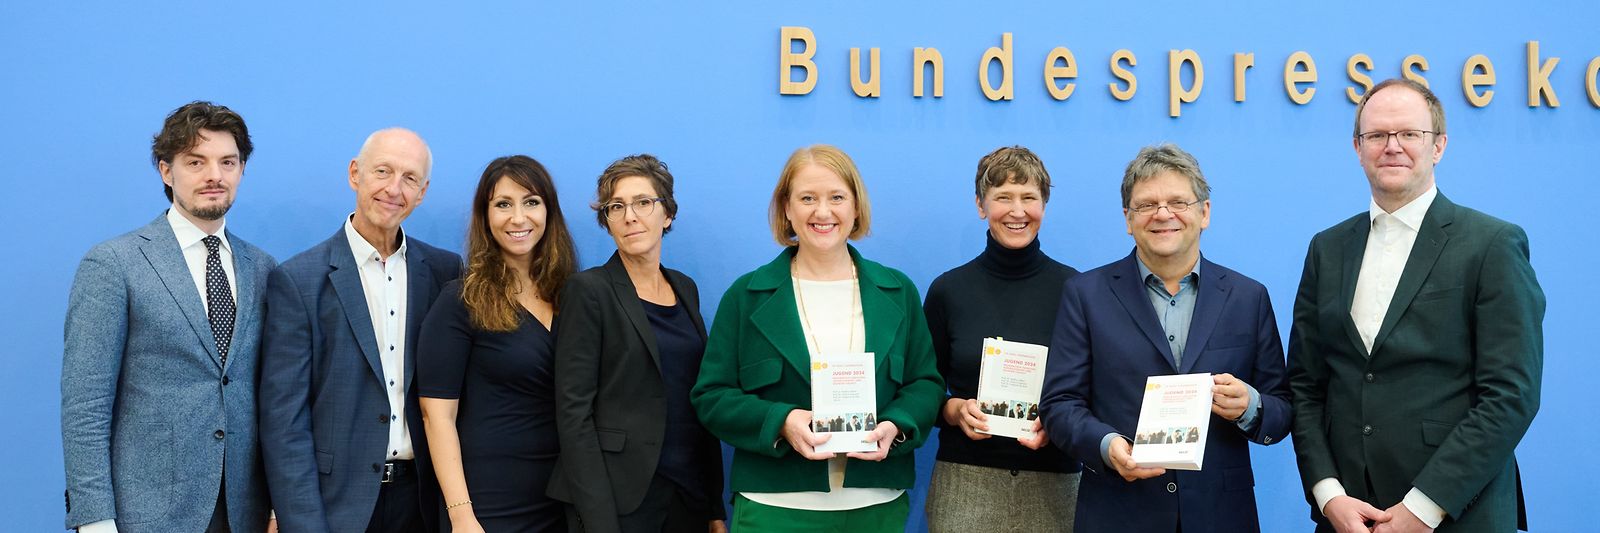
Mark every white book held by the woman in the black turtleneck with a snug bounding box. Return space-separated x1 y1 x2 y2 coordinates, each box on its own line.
978 338 1050 439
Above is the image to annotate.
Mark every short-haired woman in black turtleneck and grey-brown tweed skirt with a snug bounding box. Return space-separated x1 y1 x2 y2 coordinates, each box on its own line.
923 146 1078 533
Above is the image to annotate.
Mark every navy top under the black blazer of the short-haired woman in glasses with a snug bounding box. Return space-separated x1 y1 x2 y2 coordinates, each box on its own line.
638 299 706 495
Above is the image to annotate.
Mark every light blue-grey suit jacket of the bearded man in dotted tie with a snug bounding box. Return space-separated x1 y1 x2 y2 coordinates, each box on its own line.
61 214 274 533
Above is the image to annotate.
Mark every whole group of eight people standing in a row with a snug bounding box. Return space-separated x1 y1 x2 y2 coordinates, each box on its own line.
61 73 1544 533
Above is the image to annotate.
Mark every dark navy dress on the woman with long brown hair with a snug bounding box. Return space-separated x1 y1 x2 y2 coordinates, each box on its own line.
416 280 566 531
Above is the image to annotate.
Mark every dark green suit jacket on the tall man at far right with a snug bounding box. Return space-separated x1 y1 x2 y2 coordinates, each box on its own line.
1288 194 1544 531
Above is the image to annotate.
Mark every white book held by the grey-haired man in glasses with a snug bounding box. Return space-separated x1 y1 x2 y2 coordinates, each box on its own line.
1133 375 1211 471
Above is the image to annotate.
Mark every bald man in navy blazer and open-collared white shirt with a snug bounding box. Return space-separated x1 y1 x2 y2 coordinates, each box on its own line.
261 128 461 533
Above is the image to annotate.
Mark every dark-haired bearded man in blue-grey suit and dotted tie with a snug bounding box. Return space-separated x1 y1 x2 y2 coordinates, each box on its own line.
61 102 275 533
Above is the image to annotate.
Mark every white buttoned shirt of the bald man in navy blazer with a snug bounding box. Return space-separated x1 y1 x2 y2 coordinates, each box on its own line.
344 218 416 461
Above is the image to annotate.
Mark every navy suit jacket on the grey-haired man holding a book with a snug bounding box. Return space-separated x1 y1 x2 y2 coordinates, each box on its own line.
1040 254 1290 533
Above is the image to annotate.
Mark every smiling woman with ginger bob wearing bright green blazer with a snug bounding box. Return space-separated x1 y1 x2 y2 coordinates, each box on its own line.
690 146 944 531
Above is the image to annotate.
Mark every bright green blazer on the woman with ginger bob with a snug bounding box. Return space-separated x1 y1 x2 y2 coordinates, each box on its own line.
690 246 944 493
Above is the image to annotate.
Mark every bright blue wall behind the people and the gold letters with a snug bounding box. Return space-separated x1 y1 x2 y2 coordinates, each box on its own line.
0 0 1600 531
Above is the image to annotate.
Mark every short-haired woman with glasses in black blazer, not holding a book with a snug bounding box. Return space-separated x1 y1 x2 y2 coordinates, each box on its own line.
550 154 725 533
